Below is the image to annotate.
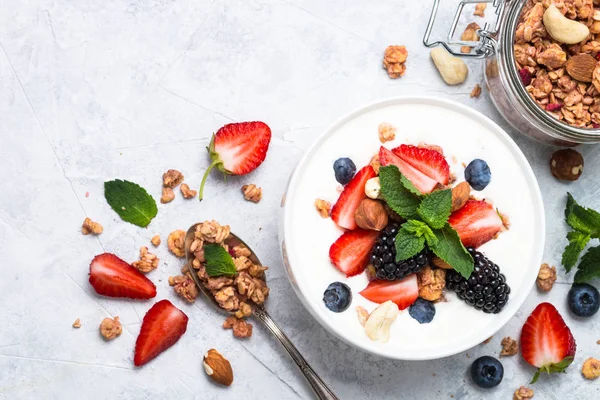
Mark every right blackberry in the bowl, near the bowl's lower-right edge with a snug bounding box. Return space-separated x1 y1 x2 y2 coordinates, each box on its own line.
446 247 510 314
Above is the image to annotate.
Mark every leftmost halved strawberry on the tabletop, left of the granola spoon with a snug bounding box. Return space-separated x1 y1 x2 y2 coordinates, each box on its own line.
90 253 156 299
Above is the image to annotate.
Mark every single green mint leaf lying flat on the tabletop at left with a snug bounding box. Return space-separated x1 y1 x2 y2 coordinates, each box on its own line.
104 179 158 227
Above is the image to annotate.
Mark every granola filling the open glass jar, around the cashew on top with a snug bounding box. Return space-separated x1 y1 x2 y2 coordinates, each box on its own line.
514 0 600 129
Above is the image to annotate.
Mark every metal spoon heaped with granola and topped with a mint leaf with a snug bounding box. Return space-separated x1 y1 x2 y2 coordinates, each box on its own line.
183 220 337 400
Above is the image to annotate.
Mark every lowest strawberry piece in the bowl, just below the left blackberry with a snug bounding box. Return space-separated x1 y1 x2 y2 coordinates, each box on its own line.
360 274 419 310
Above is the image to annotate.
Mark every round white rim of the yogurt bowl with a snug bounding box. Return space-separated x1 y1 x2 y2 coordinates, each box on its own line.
279 96 546 361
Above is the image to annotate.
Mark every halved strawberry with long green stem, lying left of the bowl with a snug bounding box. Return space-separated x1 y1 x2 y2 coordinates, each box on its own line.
199 121 271 200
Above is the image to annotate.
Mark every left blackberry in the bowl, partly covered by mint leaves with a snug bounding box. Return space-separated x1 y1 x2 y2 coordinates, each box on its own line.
369 222 431 281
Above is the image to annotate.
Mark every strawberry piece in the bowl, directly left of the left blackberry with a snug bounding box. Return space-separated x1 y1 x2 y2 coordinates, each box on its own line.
329 229 379 276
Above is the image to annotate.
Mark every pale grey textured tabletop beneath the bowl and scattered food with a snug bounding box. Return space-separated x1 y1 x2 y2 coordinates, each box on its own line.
0 0 600 400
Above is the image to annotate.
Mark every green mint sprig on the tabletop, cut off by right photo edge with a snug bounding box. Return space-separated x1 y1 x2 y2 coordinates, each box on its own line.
561 193 600 283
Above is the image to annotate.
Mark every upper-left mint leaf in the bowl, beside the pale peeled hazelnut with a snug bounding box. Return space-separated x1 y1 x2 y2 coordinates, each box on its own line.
379 165 421 219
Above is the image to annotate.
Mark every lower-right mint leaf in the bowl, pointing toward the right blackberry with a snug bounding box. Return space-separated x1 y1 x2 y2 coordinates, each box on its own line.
429 224 473 278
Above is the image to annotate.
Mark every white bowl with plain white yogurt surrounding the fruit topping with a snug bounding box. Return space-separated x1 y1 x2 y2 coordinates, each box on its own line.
280 97 545 360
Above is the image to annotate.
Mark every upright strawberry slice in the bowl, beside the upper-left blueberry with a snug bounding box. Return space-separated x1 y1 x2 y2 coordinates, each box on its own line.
331 165 377 229
